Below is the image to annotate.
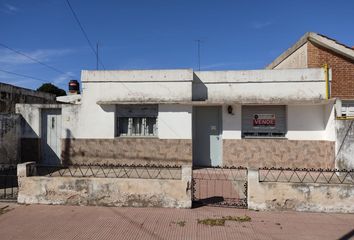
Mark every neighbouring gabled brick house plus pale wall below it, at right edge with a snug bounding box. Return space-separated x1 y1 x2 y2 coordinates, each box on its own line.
266 32 354 169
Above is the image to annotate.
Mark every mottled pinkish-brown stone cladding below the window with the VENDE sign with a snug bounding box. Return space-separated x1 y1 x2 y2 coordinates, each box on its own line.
223 139 335 168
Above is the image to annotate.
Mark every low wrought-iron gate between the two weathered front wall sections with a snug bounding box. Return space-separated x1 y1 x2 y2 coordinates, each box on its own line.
192 167 247 208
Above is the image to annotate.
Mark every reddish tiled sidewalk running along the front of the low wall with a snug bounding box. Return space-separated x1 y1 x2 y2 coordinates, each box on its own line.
0 204 354 240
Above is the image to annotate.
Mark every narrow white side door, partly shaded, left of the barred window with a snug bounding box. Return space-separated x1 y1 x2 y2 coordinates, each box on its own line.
41 109 61 165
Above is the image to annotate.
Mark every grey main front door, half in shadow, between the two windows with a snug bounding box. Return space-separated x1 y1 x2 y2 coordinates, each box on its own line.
193 106 222 166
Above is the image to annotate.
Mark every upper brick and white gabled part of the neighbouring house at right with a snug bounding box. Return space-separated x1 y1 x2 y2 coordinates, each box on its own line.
266 32 354 117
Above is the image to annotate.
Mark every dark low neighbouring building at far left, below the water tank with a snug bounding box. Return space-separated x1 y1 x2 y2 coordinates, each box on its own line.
0 83 56 113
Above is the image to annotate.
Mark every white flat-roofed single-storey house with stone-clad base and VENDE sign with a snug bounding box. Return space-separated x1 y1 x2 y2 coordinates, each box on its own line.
16 68 335 168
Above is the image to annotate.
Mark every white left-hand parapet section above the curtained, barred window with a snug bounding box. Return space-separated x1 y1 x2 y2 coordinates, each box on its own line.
81 69 193 104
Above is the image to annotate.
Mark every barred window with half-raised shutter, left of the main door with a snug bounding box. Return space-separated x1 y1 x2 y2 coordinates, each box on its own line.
116 105 158 137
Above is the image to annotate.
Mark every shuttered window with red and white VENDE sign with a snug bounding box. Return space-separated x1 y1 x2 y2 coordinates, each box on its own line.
242 105 286 138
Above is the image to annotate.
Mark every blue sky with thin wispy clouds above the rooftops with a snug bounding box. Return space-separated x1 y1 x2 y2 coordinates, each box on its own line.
0 0 354 90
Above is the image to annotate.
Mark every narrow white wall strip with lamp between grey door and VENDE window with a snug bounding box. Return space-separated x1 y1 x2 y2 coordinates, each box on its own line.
222 105 242 139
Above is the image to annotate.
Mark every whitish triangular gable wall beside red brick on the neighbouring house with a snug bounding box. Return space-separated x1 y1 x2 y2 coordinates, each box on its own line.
274 43 307 69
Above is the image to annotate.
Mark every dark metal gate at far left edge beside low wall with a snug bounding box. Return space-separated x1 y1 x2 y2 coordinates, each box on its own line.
0 164 18 201
